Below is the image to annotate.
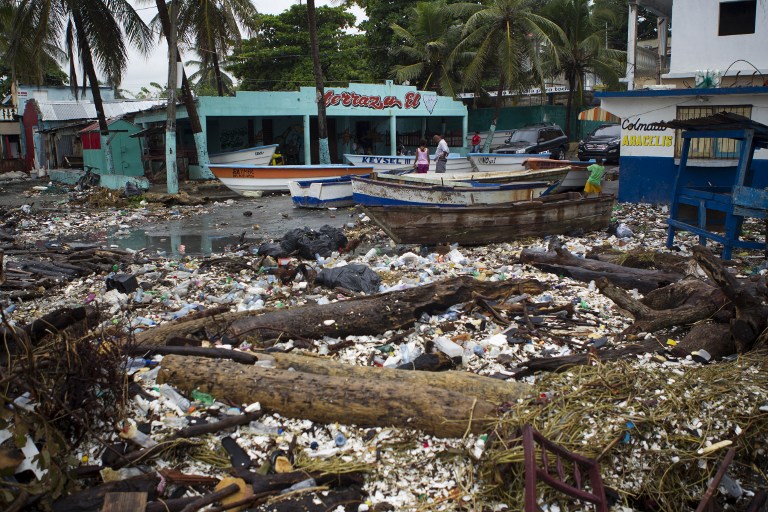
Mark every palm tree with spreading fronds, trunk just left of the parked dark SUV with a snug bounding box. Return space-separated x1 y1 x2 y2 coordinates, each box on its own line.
454 0 560 152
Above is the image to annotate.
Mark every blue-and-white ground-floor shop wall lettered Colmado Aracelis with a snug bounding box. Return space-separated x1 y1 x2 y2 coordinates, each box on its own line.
598 88 768 204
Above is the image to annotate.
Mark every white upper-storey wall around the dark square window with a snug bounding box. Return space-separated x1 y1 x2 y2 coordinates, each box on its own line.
668 0 768 78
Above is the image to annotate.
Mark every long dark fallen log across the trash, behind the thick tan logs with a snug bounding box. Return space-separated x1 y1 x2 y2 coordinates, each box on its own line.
136 276 544 345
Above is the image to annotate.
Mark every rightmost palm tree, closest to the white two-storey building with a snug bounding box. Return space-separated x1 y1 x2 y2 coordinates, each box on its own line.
544 0 625 137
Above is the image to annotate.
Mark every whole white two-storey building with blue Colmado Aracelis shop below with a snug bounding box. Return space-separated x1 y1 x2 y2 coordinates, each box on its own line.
596 0 768 203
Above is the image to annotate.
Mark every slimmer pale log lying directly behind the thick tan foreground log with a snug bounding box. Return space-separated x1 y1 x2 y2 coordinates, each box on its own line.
259 353 530 404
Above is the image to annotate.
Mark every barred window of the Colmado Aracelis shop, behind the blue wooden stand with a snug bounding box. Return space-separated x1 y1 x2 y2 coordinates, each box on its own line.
675 105 752 160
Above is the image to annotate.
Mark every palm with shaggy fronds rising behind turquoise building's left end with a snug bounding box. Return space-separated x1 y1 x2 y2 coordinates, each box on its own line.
174 0 258 96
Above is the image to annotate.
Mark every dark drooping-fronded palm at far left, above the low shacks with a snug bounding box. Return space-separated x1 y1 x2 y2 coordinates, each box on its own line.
12 0 151 174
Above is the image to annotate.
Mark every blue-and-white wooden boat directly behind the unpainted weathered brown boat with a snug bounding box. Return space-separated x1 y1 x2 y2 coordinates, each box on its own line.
352 176 549 207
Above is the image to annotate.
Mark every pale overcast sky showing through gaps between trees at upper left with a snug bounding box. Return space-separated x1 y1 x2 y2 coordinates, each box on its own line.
122 0 362 93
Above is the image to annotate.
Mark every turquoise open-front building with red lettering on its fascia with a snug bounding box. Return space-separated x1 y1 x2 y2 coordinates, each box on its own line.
134 80 468 179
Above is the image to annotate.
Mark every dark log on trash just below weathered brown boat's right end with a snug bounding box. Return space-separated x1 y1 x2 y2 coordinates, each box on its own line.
520 244 683 293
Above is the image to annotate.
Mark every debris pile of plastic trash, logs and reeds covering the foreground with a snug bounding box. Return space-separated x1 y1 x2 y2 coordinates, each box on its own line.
0 182 768 511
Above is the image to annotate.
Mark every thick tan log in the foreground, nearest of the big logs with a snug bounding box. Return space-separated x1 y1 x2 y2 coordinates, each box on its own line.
158 355 496 437
